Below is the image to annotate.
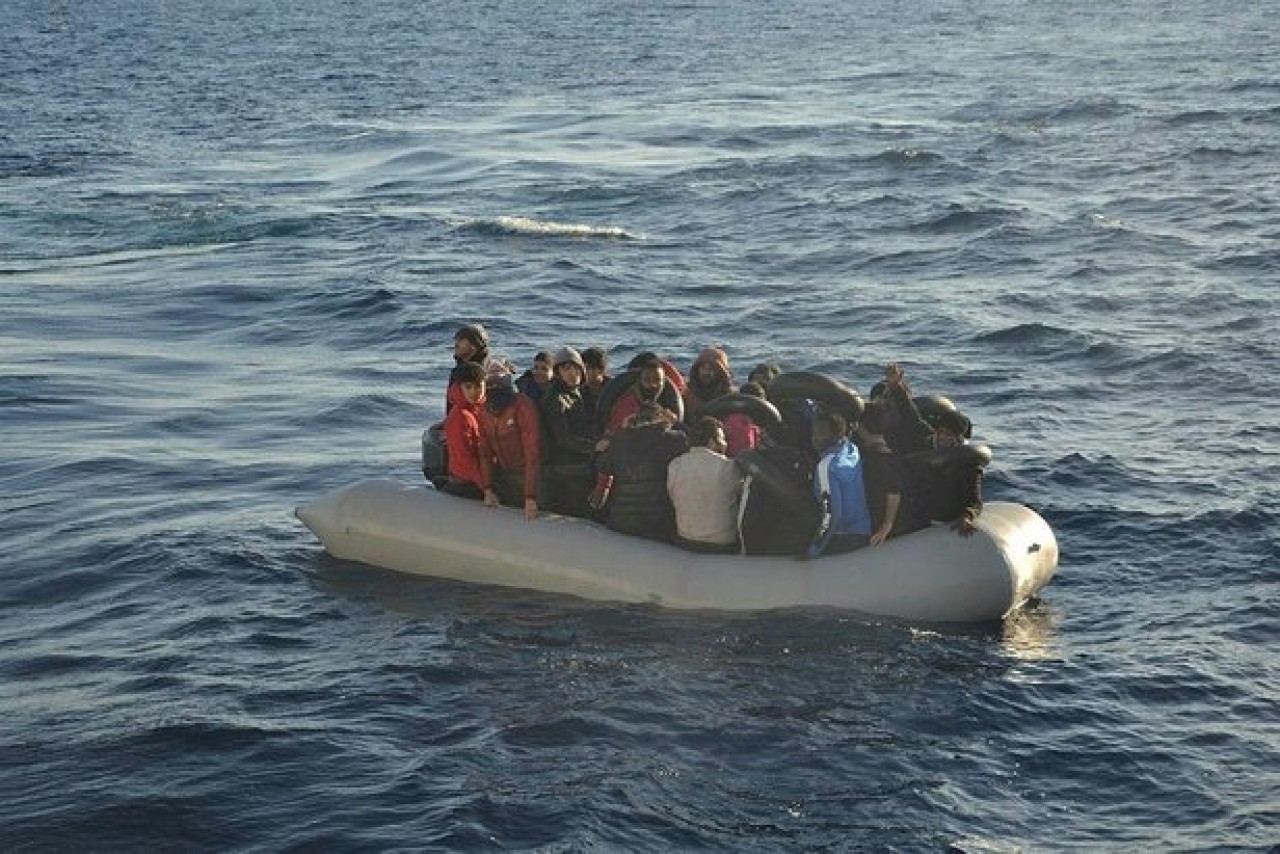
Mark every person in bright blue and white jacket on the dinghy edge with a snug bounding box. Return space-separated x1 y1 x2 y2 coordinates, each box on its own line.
808 411 872 557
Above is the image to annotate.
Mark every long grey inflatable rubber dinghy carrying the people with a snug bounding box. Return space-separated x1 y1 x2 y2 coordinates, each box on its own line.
297 480 1057 624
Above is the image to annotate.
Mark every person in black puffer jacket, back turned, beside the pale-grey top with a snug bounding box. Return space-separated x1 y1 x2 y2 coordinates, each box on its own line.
596 402 689 540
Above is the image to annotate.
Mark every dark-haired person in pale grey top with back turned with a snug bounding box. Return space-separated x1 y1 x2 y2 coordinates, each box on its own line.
667 415 742 554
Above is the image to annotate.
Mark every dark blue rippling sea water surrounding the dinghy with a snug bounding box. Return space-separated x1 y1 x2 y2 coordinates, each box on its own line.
0 0 1280 853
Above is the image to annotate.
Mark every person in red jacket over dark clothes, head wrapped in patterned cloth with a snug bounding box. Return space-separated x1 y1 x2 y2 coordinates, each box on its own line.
480 365 541 519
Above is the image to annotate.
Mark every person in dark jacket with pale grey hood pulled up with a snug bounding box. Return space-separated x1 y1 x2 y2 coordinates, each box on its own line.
541 347 599 516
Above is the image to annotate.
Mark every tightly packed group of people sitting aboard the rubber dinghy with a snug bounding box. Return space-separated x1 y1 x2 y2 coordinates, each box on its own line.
435 324 989 557
